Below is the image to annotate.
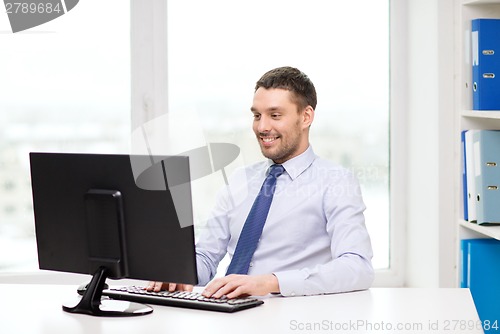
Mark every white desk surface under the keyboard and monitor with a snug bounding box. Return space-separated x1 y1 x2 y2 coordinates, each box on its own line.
0 284 483 334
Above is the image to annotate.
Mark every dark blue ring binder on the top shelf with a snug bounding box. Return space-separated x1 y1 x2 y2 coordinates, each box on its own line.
471 19 500 110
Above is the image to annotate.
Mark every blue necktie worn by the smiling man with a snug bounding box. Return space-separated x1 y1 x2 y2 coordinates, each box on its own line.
226 165 285 275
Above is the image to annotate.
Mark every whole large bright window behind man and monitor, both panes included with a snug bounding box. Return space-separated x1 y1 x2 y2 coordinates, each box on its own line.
0 0 395 282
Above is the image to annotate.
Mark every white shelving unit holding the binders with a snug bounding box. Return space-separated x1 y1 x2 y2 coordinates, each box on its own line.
455 0 500 258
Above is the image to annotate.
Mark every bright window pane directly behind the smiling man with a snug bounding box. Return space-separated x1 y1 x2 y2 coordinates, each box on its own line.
168 0 390 269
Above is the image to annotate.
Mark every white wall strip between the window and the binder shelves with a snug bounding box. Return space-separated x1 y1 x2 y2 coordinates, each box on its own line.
404 0 456 287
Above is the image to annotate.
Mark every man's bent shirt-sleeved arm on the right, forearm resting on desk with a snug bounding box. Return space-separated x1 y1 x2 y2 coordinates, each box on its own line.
274 171 374 296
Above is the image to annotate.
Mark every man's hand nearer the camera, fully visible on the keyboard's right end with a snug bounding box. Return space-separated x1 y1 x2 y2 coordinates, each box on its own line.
202 274 279 298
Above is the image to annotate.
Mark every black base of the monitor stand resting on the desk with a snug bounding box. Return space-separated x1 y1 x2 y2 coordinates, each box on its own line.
63 267 153 317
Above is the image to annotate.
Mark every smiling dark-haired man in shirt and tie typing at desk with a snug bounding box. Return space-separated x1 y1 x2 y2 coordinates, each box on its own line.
146 67 374 298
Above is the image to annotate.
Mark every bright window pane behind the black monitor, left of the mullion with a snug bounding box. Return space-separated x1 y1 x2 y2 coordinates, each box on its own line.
0 0 131 271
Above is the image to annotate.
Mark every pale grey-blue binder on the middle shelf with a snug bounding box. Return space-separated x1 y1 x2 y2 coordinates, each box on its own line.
473 130 500 224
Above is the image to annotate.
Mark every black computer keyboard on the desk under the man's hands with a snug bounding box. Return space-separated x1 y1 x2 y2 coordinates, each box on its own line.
103 286 264 312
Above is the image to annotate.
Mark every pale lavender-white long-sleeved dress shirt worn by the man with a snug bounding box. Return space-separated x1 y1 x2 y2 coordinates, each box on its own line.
196 147 374 296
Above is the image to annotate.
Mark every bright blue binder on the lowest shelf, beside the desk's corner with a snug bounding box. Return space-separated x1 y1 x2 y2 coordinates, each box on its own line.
461 239 500 332
